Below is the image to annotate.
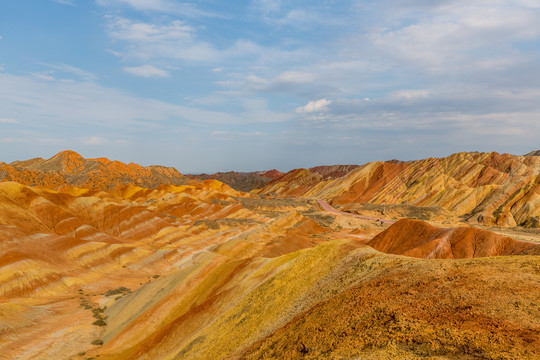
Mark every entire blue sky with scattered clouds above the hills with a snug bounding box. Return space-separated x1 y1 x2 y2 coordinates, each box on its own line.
0 0 540 173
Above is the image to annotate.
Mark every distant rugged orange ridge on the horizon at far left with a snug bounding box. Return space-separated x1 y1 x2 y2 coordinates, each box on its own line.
0 150 187 190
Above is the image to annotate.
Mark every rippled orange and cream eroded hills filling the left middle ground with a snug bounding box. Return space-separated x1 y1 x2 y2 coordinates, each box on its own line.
0 180 336 359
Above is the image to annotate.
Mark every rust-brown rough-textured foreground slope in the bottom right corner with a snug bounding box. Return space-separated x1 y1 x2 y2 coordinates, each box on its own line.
240 250 540 360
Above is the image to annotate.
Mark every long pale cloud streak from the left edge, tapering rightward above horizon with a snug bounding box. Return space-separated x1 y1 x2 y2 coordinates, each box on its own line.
0 74 287 129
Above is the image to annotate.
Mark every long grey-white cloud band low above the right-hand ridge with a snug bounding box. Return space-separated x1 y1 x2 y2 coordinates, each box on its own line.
301 85 540 141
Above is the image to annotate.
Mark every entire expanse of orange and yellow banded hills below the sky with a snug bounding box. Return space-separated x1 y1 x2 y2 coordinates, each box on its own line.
0 151 540 360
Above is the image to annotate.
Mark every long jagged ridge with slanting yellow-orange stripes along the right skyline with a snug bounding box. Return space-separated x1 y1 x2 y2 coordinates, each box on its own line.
255 152 540 227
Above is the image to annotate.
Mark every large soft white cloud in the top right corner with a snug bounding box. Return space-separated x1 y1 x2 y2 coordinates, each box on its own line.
370 1 540 73
